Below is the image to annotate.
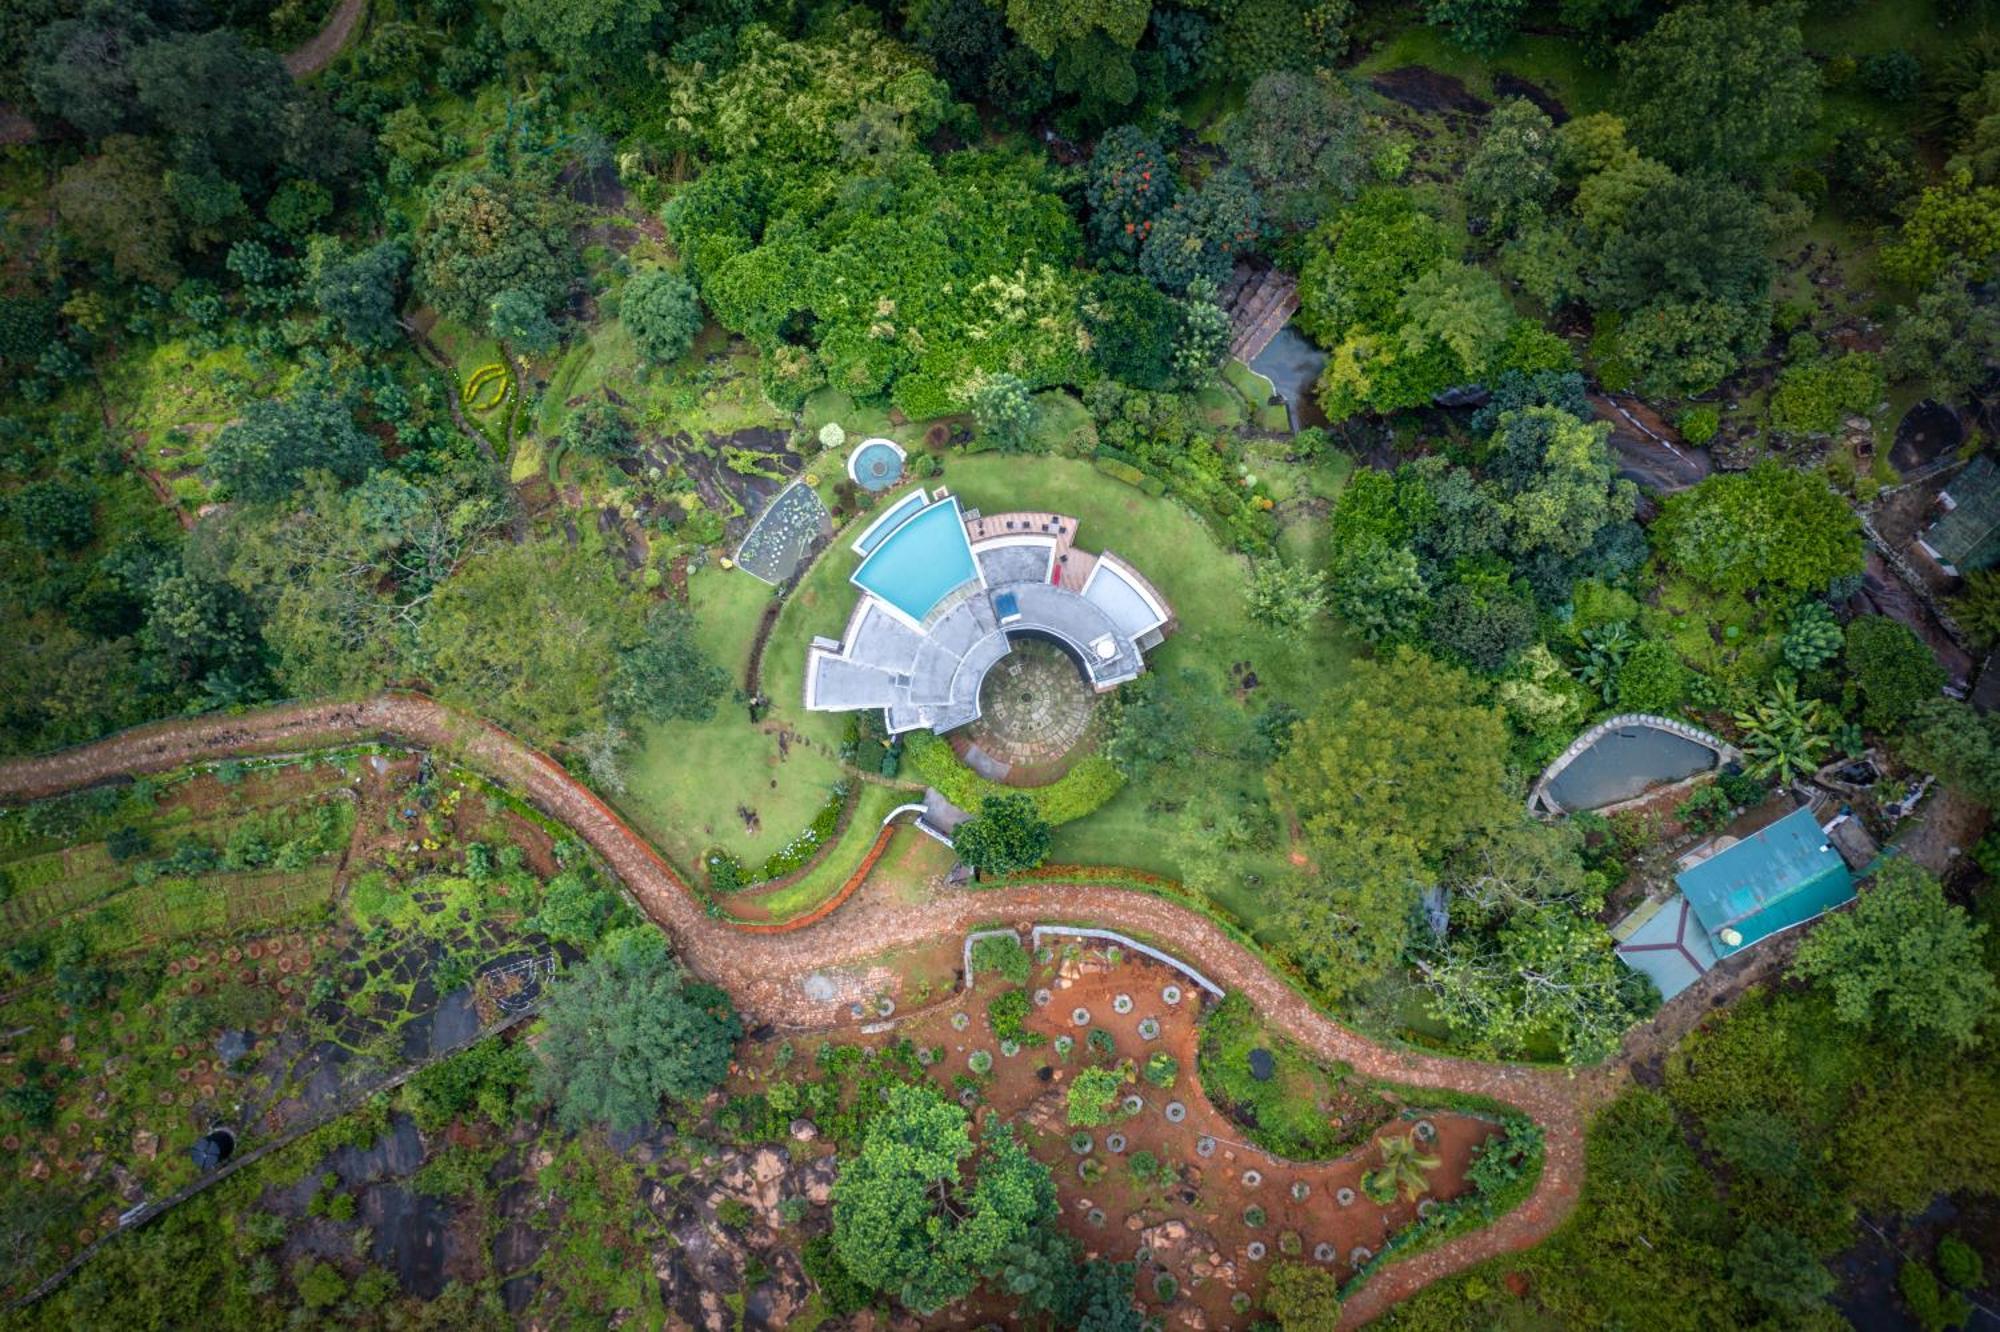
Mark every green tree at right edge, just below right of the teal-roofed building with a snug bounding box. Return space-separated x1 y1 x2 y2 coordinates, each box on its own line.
1792 856 2000 1052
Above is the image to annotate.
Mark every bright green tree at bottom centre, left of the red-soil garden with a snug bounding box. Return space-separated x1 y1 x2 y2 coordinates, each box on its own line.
834 1084 1056 1314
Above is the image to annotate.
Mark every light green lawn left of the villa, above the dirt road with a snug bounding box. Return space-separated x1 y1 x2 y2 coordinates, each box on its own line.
618 568 840 874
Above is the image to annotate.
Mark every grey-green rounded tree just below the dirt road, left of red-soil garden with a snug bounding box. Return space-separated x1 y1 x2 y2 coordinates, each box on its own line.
536 924 742 1132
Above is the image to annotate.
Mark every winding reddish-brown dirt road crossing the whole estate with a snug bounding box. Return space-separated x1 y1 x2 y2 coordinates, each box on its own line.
0 694 1626 1322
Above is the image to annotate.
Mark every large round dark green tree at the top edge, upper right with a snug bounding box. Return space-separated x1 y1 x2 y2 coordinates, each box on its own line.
1618 0 1820 172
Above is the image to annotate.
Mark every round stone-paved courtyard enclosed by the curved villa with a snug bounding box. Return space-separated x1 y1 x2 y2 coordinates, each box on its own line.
952 638 1098 786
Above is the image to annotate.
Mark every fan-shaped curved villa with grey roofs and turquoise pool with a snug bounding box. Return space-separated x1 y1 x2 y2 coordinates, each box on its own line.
806 486 1174 734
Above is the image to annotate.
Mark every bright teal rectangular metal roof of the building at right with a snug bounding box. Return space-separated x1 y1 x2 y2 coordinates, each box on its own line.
1674 810 1854 958
